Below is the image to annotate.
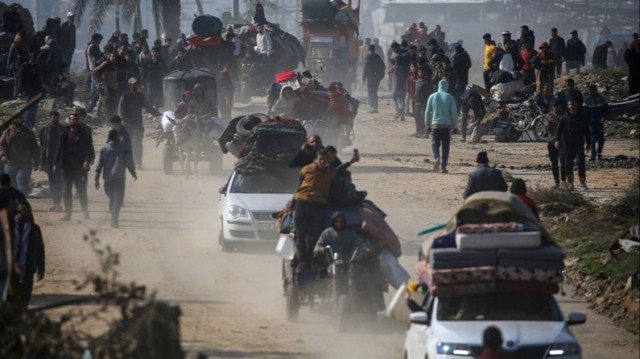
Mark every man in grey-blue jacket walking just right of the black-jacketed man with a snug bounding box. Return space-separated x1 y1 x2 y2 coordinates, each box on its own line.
95 130 138 228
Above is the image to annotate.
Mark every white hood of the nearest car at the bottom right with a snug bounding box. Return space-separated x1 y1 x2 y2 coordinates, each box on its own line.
433 321 576 350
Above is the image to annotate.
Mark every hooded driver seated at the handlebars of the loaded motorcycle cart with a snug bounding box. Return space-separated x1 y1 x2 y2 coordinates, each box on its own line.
313 212 369 259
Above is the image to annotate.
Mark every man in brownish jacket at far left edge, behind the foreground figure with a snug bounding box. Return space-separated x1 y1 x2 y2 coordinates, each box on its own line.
0 118 40 197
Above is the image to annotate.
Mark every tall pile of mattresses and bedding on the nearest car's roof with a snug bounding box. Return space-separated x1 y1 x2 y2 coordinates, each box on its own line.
416 192 564 297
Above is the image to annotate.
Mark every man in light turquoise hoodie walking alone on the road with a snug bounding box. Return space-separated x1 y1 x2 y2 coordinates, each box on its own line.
424 80 458 173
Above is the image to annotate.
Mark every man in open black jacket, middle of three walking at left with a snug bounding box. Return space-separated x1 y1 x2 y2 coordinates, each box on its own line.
53 113 94 221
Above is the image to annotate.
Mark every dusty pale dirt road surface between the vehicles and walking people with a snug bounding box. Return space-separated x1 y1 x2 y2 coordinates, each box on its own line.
32 93 639 359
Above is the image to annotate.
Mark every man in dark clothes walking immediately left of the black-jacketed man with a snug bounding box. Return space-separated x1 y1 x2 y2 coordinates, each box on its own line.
39 111 65 212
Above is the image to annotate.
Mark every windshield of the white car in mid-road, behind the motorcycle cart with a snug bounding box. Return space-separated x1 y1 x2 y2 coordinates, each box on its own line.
229 171 298 194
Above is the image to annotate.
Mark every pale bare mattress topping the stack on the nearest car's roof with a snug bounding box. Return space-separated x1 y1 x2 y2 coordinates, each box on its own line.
456 231 542 249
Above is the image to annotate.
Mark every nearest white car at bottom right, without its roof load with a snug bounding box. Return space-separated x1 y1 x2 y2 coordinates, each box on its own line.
404 293 587 359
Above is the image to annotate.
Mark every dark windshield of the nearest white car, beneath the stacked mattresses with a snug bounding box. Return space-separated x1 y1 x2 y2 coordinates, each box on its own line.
437 293 562 321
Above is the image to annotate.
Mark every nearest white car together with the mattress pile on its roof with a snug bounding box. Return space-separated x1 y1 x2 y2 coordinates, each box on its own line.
398 192 587 359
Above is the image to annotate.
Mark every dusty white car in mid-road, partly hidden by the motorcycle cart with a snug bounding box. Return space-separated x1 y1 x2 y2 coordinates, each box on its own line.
218 168 299 251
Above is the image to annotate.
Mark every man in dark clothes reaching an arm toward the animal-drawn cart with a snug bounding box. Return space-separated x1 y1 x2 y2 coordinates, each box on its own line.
118 77 162 169
